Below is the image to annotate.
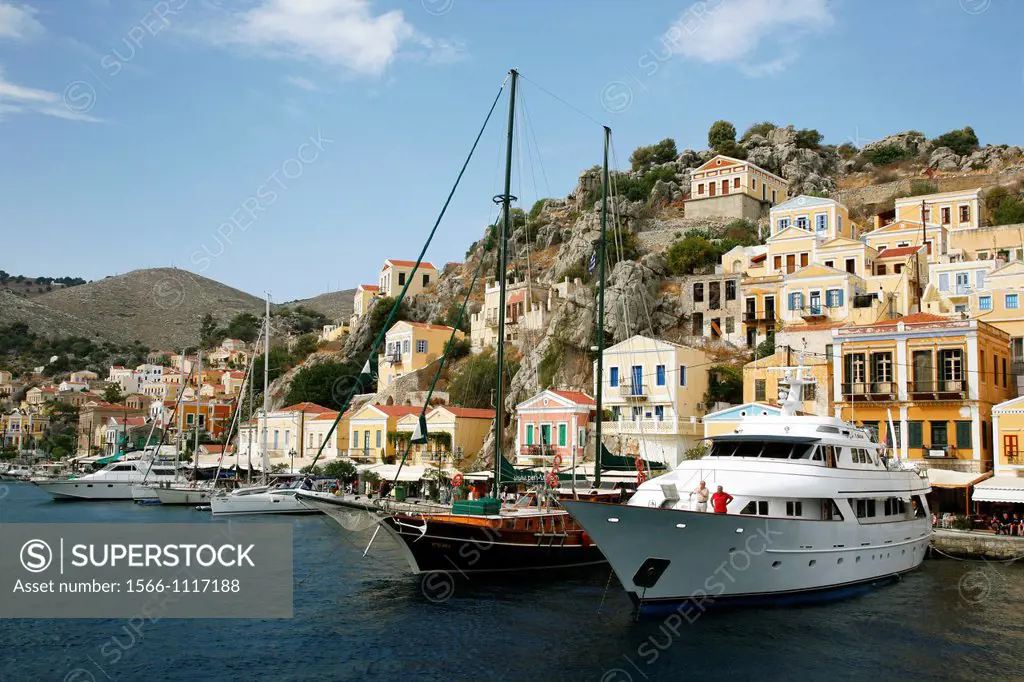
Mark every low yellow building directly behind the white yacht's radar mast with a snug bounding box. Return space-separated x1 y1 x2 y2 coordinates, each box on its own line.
743 350 833 416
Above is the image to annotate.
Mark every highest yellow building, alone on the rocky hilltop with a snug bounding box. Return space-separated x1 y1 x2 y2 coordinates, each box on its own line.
686 154 788 220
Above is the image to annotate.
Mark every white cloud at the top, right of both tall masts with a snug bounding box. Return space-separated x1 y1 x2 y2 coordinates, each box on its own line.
662 0 836 75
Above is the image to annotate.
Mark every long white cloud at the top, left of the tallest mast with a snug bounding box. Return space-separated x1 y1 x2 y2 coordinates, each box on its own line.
194 0 458 76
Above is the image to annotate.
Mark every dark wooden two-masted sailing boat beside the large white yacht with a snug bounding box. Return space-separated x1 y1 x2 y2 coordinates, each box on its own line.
299 70 611 576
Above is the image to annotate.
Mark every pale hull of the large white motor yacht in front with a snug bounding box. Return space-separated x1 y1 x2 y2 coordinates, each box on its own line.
562 502 931 611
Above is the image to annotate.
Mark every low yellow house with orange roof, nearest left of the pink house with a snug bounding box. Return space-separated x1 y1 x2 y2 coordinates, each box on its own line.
397 404 495 469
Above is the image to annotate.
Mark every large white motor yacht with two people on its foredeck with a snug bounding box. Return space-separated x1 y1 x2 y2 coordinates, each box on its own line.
562 370 931 612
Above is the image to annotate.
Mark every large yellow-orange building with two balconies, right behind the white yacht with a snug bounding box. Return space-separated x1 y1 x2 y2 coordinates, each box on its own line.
833 313 1013 473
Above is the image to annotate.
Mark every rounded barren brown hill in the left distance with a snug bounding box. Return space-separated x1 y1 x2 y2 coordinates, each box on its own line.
34 267 263 348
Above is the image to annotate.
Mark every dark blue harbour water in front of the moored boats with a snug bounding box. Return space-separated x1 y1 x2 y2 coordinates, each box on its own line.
0 483 1024 682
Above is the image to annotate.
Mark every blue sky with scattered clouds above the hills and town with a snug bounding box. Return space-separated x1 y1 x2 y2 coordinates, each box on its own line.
0 0 1024 301
